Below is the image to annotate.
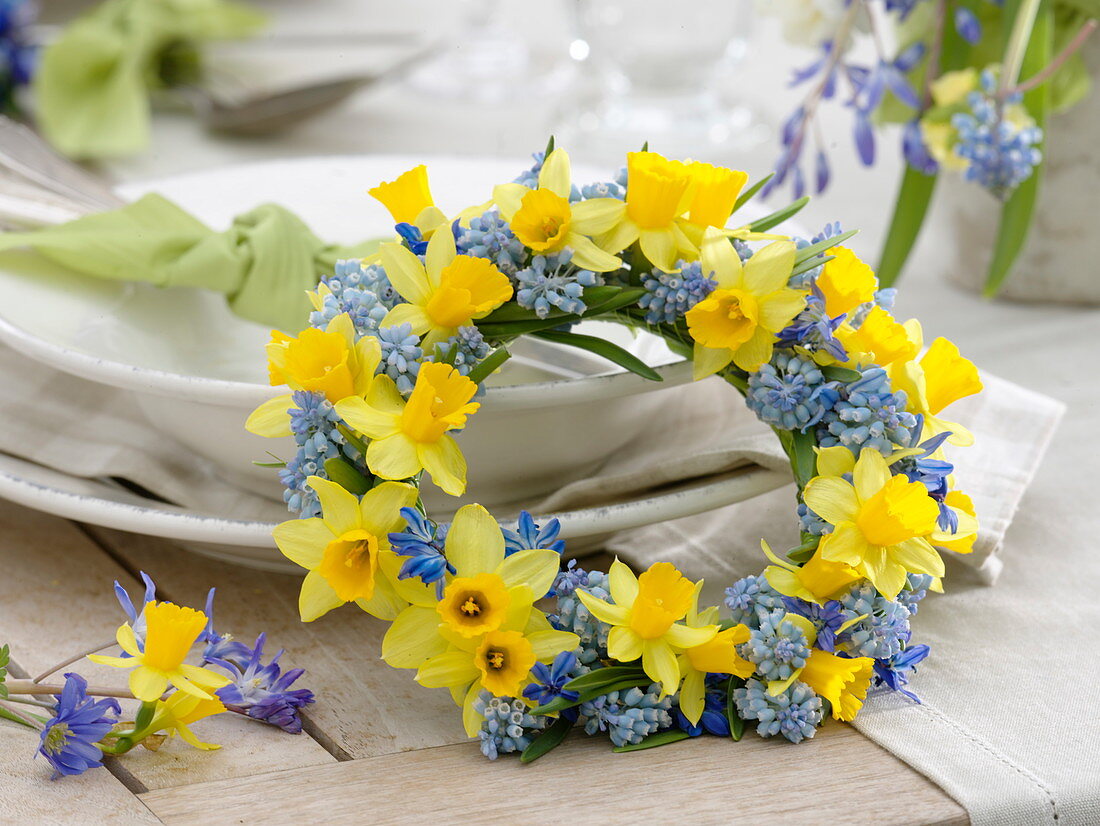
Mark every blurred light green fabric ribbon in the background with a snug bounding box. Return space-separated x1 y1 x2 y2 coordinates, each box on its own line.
33 0 264 158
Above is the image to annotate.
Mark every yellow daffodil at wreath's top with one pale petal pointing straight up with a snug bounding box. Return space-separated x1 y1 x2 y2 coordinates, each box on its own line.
493 150 623 273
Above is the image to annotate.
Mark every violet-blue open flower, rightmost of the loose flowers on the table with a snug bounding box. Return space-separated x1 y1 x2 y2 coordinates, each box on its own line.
213 634 314 735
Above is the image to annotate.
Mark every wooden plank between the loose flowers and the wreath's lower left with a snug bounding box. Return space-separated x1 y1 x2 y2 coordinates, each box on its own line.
89 528 466 758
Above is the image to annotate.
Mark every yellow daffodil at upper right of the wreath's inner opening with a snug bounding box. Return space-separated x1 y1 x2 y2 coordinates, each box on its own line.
686 227 805 378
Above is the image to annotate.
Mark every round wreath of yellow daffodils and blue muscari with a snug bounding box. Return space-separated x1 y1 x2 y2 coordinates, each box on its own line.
246 140 981 762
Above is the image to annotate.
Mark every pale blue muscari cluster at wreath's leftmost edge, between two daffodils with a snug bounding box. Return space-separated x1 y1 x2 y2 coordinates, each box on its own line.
278 390 365 519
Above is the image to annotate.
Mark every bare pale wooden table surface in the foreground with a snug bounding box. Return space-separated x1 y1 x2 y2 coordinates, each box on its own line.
0 502 968 825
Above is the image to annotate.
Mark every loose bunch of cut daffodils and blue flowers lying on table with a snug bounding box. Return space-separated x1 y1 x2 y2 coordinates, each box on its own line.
18 572 314 780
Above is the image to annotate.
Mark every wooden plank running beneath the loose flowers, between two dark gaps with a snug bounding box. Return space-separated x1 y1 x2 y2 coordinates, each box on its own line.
0 503 336 789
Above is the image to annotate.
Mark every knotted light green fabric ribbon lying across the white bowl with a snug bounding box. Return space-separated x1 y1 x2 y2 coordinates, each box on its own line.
0 194 377 334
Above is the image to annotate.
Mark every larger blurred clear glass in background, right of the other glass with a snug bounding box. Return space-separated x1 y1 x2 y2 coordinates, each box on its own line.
563 0 768 158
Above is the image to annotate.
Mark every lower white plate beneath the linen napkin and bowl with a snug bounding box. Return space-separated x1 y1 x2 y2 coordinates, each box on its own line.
0 453 791 572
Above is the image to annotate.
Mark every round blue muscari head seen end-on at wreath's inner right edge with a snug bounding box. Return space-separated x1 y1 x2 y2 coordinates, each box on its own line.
745 350 840 433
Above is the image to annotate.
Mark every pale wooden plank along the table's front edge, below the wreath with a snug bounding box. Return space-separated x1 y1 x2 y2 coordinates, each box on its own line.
141 723 968 826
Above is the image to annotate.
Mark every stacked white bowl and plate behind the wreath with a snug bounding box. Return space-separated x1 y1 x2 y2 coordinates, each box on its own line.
0 156 784 569
